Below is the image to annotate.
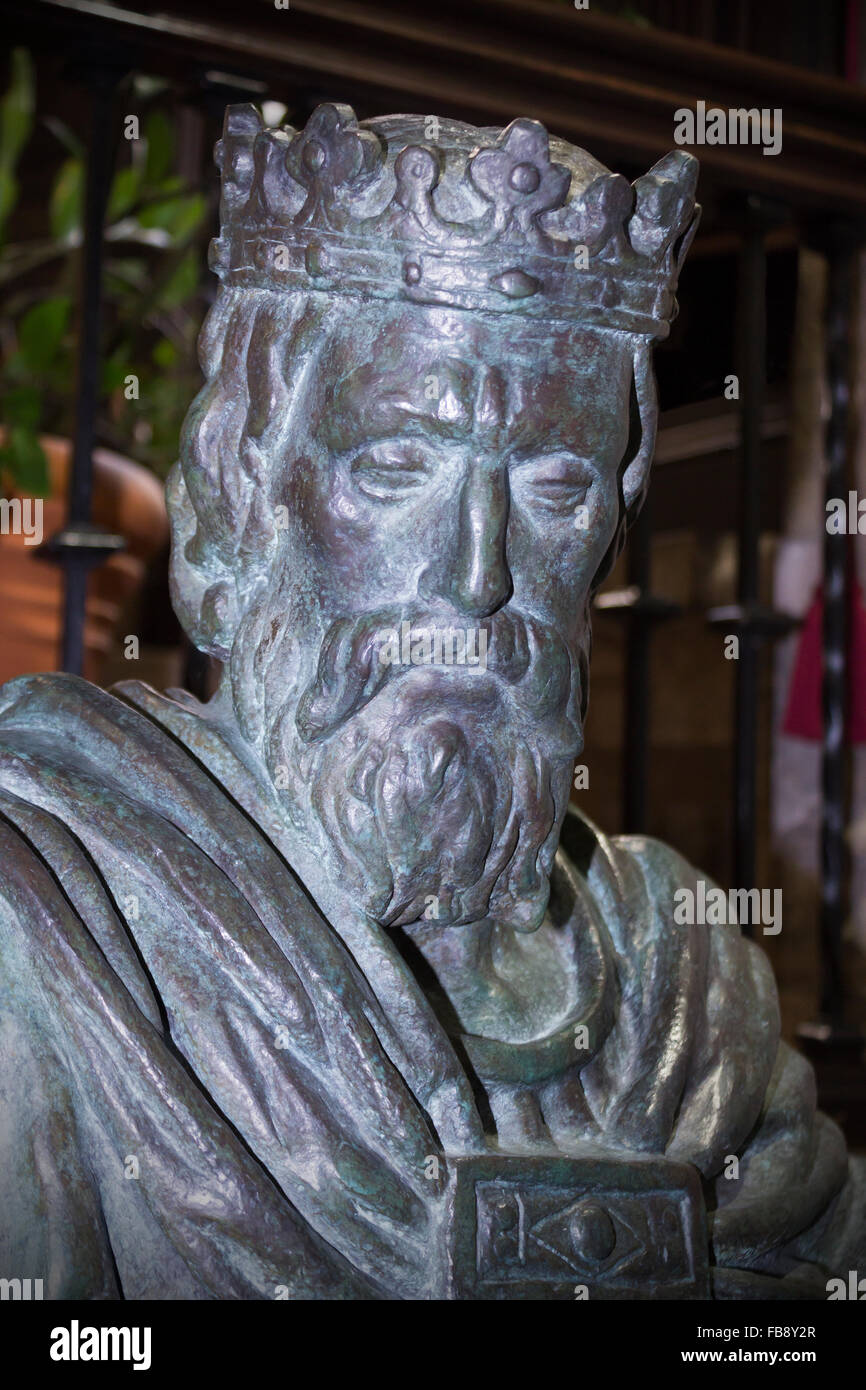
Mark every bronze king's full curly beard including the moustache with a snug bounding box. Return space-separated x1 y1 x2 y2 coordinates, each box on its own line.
232 589 588 931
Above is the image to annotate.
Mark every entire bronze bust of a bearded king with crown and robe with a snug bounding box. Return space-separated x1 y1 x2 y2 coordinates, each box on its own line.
0 104 866 1298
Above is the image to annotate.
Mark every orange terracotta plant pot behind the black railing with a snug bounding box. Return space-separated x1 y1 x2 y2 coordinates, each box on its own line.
0 430 168 684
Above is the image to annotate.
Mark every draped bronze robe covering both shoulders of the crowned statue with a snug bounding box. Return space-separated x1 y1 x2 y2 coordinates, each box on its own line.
0 676 866 1298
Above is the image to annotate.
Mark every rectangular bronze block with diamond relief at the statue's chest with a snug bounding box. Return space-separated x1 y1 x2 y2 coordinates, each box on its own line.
448 1154 710 1300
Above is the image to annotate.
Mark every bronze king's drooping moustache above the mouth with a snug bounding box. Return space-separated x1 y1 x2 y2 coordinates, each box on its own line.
295 605 573 744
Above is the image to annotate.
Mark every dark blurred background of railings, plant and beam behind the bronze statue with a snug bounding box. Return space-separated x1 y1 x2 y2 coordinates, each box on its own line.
0 0 866 1144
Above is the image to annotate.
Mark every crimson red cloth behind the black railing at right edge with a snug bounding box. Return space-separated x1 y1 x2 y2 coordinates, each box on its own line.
781 580 866 744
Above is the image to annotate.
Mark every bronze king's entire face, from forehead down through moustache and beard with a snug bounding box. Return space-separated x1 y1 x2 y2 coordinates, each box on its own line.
232 300 632 930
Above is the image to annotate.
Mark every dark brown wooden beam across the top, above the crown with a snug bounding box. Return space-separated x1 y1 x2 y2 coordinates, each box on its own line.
4 0 866 213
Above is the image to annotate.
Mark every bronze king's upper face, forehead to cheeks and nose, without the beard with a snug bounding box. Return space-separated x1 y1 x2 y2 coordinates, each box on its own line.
274 303 631 644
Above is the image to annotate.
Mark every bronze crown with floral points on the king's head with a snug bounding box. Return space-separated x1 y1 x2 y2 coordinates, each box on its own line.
210 103 701 338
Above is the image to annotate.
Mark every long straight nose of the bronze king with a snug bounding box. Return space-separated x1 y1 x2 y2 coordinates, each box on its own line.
421 464 513 617
